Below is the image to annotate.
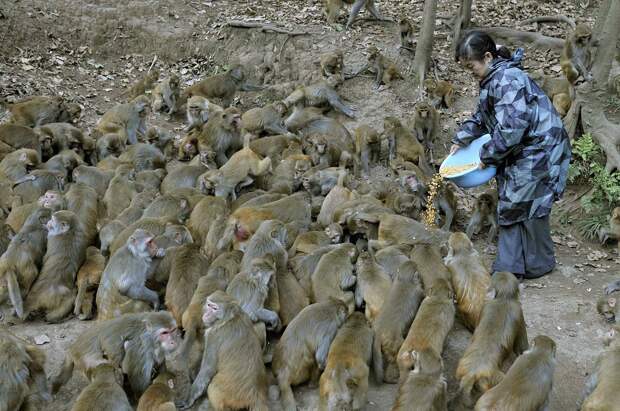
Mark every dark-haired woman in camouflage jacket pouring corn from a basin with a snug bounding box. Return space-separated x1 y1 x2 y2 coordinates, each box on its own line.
450 31 571 278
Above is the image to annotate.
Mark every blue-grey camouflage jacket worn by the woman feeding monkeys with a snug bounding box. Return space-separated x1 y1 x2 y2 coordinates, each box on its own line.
453 49 571 225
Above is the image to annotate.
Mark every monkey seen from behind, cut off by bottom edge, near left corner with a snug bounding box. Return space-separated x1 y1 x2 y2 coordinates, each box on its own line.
71 363 133 411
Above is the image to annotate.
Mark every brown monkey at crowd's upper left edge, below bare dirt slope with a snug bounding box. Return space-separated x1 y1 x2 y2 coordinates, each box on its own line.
8 96 65 127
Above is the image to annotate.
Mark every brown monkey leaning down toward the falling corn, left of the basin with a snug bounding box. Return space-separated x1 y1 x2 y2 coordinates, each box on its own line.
383 117 435 175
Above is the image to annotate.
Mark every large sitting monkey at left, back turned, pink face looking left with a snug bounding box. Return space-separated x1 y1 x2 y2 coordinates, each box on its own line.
25 210 86 322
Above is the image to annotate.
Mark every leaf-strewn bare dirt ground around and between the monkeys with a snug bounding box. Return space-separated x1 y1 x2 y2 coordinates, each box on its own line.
0 0 620 410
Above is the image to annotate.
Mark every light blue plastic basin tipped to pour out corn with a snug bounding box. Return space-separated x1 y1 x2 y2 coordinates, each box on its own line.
440 134 497 188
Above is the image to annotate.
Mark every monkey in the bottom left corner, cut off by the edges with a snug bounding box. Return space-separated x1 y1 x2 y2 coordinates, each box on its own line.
0 327 52 410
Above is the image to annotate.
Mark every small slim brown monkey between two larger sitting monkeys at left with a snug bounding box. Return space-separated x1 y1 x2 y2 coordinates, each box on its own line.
73 247 105 320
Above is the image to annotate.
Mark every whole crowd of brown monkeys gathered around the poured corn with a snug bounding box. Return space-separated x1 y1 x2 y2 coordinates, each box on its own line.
0 0 620 411
